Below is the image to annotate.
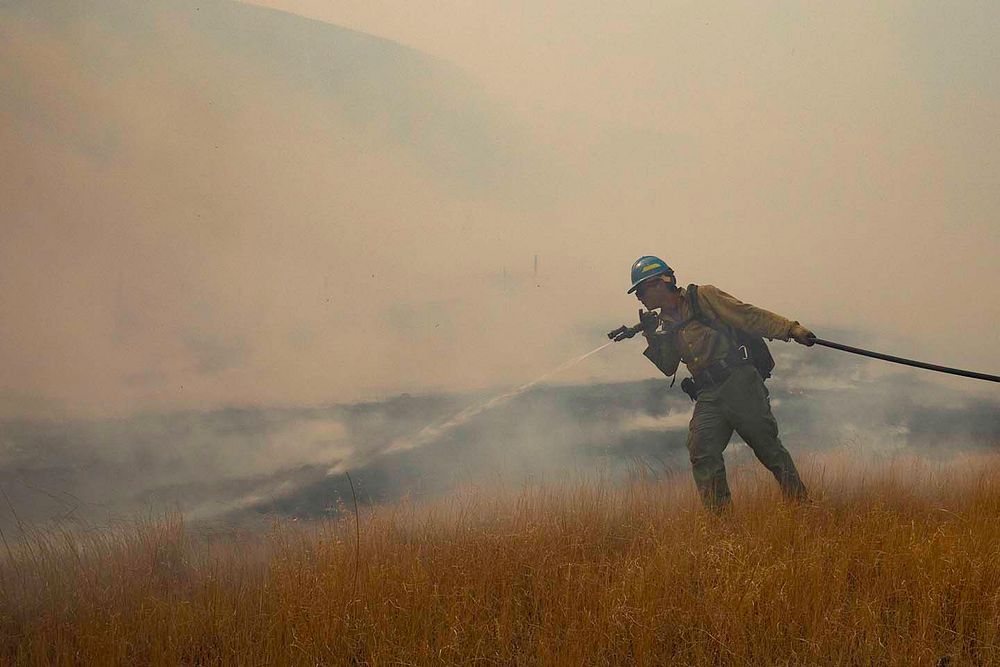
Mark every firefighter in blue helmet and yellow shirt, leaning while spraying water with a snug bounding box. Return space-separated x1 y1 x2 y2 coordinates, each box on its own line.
628 255 815 512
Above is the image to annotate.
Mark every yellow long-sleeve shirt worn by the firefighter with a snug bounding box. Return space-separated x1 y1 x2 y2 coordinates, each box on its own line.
643 285 798 375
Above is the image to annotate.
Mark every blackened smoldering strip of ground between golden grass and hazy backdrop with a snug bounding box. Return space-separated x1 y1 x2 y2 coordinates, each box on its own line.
0 343 1000 527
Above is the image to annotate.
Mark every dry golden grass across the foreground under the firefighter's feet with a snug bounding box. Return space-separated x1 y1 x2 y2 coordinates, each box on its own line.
0 457 1000 665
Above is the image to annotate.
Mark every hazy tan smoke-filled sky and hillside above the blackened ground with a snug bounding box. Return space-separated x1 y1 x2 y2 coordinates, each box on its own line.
0 0 1000 415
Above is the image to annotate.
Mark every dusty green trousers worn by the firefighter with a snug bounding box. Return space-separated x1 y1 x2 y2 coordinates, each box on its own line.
687 365 806 510
